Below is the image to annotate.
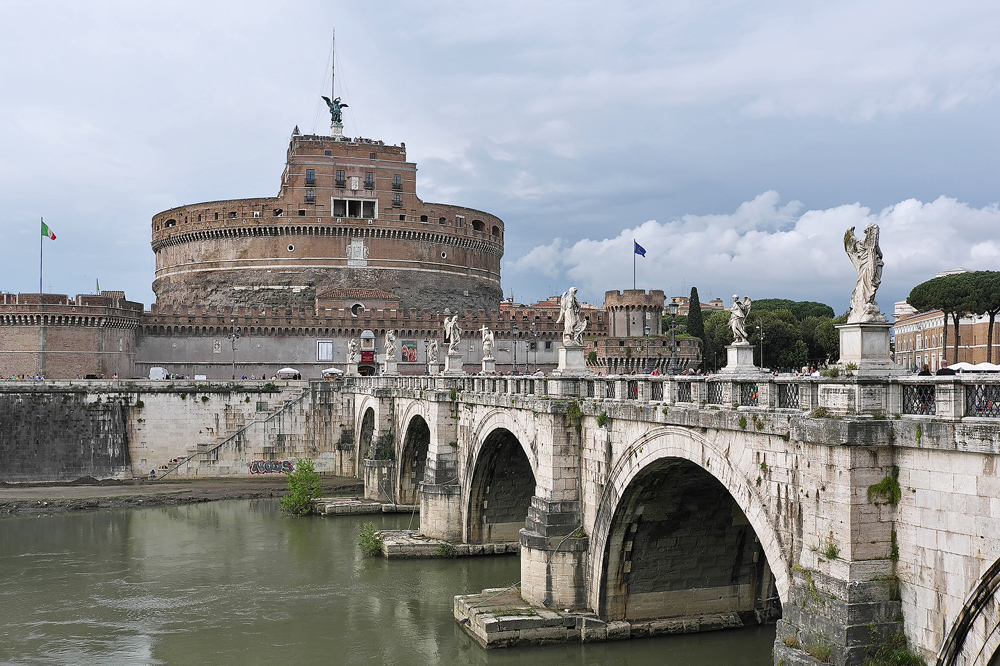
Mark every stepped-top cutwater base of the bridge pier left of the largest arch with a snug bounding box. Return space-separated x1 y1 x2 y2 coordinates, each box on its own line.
520 496 590 608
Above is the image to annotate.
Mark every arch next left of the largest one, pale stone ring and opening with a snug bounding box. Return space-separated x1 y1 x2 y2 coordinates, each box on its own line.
463 410 537 543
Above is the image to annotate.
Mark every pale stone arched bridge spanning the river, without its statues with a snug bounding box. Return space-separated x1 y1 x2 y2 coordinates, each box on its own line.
343 374 1000 666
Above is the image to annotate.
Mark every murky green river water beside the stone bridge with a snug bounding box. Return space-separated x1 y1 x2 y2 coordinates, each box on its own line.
0 500 774 666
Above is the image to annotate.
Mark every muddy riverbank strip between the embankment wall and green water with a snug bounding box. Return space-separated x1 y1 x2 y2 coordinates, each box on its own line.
0 475 364 516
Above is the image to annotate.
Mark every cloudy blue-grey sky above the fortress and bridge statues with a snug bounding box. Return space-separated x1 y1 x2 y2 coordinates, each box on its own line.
0 0 1000 314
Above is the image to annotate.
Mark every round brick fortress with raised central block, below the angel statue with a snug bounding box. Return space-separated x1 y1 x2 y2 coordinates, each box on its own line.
152 133 503 311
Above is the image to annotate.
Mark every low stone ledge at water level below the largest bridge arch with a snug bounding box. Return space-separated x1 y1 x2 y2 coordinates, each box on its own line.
455 588 744 649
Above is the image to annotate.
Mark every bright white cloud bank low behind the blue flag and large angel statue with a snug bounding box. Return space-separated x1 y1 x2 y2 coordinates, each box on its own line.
507 191 1000 312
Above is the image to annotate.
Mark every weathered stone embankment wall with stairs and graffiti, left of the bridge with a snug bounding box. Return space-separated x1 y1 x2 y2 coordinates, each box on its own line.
0 381 355 482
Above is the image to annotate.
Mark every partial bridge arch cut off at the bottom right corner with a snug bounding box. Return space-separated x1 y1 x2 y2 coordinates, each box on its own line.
934 559 1000 666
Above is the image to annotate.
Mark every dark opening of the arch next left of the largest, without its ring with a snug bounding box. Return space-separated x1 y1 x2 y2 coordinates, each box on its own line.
467 428 535 543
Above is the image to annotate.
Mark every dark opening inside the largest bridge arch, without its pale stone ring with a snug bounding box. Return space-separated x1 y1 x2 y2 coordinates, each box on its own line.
600 457 781 628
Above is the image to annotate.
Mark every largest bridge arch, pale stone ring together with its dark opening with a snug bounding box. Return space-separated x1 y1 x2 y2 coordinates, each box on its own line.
588 426 791 619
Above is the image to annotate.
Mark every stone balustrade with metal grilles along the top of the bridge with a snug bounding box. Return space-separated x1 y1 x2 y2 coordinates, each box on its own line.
347 373 1000 419
